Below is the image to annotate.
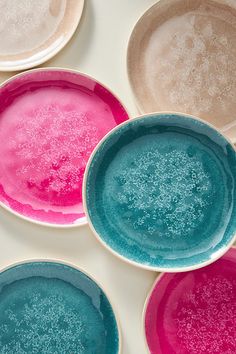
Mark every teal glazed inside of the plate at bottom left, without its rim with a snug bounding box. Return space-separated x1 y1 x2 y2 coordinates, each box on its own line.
0 262 119 354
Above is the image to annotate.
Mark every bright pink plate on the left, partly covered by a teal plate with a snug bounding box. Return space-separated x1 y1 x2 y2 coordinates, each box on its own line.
0 69 128 226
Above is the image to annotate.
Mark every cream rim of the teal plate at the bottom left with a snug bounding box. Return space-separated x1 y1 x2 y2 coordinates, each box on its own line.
0 257 123 354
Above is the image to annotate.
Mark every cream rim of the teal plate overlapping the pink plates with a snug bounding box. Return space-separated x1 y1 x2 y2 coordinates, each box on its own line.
82 111 236 273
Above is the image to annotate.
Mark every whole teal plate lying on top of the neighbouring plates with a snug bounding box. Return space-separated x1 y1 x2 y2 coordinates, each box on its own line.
83 113 236 272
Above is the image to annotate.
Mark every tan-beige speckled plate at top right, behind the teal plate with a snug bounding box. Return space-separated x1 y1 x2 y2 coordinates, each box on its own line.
127 0 236 142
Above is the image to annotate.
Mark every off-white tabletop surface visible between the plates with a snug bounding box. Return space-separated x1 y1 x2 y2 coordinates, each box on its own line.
0 0 159 354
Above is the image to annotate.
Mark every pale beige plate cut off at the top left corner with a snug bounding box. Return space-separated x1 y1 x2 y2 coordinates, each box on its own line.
0 0 84 71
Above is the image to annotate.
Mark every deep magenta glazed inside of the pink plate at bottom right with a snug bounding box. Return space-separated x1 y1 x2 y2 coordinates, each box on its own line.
145 248 236 354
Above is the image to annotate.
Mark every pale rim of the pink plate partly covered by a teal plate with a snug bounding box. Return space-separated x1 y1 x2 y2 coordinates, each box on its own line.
0 66 131 229
